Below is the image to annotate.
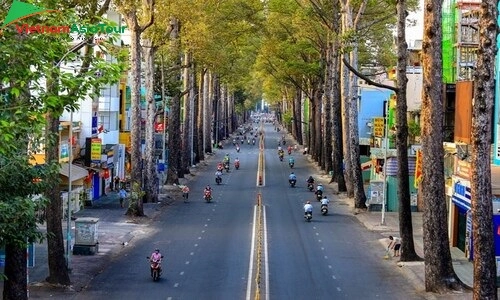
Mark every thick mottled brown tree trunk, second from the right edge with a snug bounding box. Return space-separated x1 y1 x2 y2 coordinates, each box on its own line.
420 0 458 293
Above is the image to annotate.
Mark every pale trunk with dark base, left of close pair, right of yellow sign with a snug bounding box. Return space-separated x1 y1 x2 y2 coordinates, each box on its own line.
124 11 144 216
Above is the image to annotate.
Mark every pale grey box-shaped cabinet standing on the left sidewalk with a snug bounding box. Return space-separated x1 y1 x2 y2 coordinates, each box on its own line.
73 218 99 255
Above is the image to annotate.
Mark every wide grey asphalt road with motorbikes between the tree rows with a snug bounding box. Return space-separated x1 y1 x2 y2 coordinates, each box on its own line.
75 125 420 300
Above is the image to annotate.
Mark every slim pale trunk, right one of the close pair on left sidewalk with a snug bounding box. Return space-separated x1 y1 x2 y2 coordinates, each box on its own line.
142 39 159 202
